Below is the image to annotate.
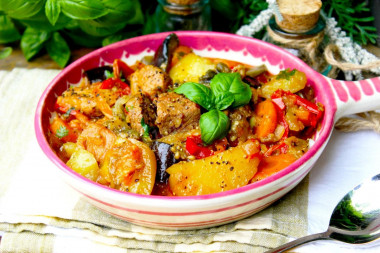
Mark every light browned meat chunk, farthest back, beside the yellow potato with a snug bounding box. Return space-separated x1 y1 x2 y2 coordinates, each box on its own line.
131 65 172 100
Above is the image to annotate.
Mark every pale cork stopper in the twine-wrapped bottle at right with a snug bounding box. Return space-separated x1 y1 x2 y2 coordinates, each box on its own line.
276 0 322 33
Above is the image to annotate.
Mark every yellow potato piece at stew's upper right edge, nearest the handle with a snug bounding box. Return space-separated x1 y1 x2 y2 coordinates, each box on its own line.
260 69 307 98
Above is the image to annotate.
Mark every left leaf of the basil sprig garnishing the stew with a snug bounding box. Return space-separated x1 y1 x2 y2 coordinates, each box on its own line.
174 82 215 110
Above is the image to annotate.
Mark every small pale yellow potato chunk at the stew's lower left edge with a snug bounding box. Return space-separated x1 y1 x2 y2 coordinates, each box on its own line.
66 148 99 181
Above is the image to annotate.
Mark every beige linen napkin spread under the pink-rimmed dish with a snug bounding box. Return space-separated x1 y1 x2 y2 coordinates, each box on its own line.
0 69 308 253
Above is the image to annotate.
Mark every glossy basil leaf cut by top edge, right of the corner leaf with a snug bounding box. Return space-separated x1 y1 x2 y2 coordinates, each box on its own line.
61 0 107 20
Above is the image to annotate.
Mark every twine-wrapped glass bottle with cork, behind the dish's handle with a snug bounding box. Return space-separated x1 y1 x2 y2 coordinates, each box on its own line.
265 0 336 77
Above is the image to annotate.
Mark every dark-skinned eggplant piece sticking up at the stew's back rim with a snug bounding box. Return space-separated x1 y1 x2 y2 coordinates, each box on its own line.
153 33 179 72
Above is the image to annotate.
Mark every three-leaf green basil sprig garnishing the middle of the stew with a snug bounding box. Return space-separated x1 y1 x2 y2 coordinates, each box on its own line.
174 73 252 145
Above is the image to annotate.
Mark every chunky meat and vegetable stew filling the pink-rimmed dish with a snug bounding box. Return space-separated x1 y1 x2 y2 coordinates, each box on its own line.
48 33 324 196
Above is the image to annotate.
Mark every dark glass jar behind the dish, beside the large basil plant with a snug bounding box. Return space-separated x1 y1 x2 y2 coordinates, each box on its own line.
155 0 211 32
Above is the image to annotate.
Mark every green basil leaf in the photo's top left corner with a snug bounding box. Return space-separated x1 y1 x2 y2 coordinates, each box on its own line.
0 0 45 19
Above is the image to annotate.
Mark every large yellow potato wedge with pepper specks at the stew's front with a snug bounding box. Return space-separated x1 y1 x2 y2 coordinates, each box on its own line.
166 140 260 196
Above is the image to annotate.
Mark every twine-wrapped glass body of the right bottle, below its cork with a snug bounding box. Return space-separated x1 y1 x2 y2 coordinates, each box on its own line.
264 17 332 76
